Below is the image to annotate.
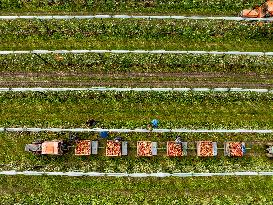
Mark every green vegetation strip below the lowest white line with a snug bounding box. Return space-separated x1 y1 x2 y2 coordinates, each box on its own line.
0 176 273 205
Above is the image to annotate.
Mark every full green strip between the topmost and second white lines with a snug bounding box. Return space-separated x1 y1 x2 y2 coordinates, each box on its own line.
0 19 272 51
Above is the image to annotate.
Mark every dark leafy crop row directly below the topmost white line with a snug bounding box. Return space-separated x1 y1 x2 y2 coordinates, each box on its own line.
0 19 273 42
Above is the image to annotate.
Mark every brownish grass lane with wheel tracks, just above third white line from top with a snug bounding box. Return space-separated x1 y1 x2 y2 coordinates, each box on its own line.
0 71 273 89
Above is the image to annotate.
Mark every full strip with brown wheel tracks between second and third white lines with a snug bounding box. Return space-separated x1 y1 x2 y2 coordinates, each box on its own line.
0 53 273 88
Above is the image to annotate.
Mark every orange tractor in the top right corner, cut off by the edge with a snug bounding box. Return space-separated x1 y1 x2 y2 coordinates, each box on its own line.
240 0 273 18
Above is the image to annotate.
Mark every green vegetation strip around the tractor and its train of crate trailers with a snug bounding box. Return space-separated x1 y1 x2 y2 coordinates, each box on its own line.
0 132 273 173
